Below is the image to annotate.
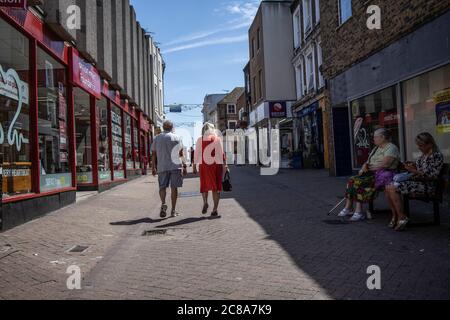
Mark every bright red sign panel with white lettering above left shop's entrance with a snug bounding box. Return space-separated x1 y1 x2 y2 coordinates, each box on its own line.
71 49 102 99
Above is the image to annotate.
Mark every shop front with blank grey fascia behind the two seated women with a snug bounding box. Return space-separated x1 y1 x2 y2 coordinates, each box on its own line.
330 12 450 175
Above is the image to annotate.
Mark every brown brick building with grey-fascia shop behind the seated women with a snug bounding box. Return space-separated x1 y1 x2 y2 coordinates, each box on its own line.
321 0 450 175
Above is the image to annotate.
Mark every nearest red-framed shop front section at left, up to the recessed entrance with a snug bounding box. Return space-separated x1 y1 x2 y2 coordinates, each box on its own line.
0 8 76 230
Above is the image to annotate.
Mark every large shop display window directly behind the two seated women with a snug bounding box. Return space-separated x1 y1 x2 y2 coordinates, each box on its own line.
344 64 450 170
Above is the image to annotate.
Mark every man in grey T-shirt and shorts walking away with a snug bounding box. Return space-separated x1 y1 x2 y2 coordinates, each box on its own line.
152 121 187 218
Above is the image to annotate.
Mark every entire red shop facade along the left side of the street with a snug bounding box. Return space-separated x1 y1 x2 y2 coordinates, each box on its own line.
0 8 151 230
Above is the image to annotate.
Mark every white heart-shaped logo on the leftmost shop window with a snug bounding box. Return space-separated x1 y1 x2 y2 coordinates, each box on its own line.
0 65 29 152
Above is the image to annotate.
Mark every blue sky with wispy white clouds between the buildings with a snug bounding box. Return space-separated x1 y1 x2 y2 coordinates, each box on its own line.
131 0 260 104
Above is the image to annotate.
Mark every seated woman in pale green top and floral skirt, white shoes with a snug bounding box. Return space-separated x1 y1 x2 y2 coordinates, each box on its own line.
339 129 400 222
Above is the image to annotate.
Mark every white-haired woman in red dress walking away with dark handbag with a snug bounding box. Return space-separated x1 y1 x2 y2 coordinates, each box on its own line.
194 123 228 217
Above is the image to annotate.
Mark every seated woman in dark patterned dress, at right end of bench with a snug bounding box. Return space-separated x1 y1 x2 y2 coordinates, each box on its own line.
386 132 444 231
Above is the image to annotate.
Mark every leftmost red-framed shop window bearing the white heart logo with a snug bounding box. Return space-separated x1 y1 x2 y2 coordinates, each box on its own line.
0 19 32 197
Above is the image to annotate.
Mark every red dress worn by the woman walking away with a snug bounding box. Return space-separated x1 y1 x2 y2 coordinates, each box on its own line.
195 135 225 193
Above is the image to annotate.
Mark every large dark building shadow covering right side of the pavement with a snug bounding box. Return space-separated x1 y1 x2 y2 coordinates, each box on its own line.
223 167 450 299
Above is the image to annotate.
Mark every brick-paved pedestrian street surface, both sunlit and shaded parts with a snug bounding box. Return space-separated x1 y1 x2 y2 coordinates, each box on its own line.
0 167 450 300
